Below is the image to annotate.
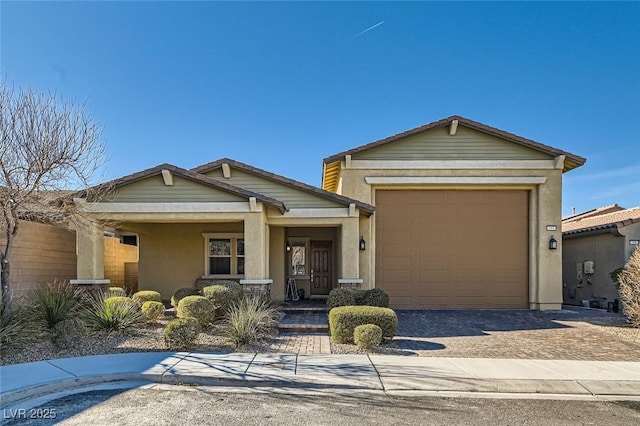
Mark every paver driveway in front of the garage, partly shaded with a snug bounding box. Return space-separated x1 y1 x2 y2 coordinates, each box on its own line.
388 308 640 361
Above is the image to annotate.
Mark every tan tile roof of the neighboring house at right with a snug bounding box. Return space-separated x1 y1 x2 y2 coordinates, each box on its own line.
562 204 640 235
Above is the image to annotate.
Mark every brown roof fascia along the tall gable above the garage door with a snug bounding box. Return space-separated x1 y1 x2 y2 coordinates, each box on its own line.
323 115 587 172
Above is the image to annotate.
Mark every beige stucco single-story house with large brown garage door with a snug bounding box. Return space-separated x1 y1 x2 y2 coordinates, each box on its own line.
76 116 585 309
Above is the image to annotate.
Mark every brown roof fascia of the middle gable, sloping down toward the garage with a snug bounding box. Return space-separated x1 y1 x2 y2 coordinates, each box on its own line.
191 158 375 216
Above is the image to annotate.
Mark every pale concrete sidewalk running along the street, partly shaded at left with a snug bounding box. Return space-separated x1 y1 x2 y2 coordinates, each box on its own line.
0 352 640 408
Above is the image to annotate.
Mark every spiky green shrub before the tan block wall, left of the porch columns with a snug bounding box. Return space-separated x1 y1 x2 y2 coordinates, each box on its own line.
33 280 79 329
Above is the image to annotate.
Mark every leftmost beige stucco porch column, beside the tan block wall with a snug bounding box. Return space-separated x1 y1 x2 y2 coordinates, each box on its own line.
76 220 104 280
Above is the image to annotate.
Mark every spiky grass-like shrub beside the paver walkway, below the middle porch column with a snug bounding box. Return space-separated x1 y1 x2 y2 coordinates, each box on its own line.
224 297 280 346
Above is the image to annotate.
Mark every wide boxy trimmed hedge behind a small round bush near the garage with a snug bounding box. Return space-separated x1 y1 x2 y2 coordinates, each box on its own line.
329 306 398 343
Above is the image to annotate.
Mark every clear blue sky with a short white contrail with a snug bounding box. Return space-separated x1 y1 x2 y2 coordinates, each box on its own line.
0 1 640 215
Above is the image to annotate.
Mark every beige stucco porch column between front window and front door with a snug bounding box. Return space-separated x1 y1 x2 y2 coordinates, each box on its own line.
244 212 267 280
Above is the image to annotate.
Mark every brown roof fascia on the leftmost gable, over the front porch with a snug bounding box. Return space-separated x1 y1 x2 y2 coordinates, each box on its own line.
72 163 289 214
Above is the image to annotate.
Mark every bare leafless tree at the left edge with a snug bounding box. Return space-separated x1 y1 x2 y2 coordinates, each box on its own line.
0 82 108 308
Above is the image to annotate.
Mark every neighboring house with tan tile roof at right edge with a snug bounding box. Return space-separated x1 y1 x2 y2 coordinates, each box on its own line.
562 204 640 308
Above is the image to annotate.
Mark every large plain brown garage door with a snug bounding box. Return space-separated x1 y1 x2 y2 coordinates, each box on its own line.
375 190 529 308
